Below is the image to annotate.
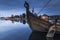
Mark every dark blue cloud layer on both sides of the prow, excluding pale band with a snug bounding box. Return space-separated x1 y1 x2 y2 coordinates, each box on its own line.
0 0 60 14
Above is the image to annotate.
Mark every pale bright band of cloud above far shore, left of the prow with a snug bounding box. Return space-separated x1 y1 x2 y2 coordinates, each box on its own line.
0 9 25 17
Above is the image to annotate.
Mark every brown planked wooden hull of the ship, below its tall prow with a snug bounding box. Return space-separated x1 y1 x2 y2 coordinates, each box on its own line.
27 13 60 34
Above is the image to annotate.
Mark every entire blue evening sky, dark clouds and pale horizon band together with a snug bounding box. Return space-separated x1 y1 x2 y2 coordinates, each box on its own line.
0 0 60 17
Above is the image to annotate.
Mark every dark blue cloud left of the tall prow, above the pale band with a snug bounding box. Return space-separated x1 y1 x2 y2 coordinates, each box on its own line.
0 0 24 10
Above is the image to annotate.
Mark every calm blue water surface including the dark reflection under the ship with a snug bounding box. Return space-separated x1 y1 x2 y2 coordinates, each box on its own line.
0 21 60 40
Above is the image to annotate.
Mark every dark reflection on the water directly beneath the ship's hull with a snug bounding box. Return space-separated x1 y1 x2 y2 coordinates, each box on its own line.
29 31 60 40
